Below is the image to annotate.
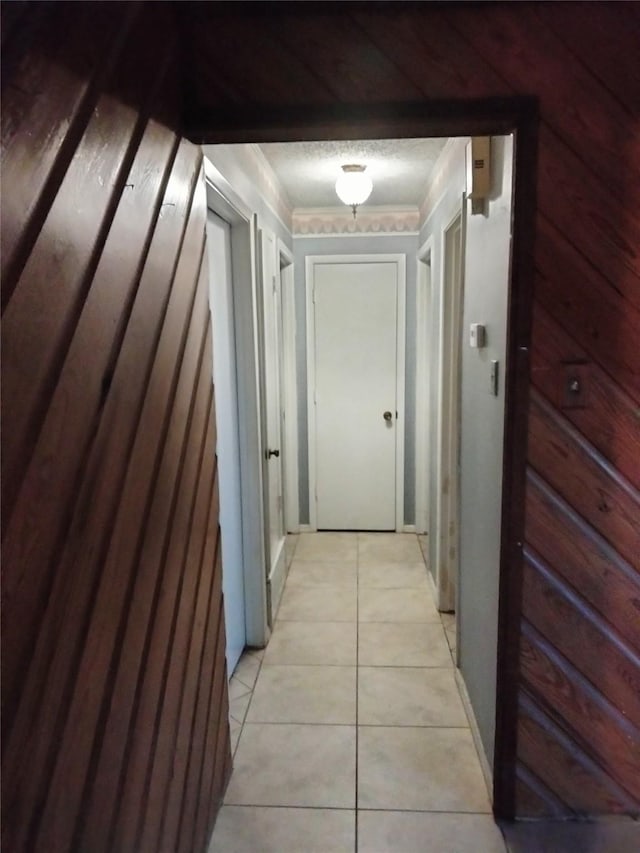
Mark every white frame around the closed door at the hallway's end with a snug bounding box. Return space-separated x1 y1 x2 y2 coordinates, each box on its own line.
305 254 407 533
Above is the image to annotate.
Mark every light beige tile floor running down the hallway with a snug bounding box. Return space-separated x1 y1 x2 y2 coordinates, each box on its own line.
210 533 505 853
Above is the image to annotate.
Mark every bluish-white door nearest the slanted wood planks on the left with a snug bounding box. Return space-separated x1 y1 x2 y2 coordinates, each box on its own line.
207 210 246 676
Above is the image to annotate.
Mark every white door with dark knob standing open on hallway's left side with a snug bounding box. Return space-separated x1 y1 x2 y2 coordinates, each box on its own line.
260 229 286 621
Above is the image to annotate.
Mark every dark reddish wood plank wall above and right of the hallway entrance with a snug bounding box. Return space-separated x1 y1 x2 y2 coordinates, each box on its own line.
180 2 640 816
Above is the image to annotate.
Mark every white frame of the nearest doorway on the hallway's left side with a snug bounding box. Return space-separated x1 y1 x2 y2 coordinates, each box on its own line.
204 157 269 647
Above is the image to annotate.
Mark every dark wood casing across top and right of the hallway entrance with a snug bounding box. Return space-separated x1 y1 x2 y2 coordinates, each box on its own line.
192 96 539 820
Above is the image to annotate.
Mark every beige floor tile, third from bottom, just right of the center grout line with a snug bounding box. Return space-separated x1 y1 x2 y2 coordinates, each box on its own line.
358 666 468 727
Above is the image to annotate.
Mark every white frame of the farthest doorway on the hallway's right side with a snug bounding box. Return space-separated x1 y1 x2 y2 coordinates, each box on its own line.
415 236 433 534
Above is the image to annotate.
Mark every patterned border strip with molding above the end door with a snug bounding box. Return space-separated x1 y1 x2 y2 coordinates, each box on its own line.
291 205 420 237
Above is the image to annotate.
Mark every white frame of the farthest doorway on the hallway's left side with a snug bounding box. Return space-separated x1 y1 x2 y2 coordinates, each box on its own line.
276 239 300 533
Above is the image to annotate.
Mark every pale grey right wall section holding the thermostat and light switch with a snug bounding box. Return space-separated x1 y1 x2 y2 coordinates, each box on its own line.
458 136 513 764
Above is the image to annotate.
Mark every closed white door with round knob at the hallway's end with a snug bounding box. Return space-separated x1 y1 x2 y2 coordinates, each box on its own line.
310 262 399 530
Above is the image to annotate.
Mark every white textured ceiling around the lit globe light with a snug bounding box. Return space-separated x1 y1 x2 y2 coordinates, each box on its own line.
260 139 447 208
